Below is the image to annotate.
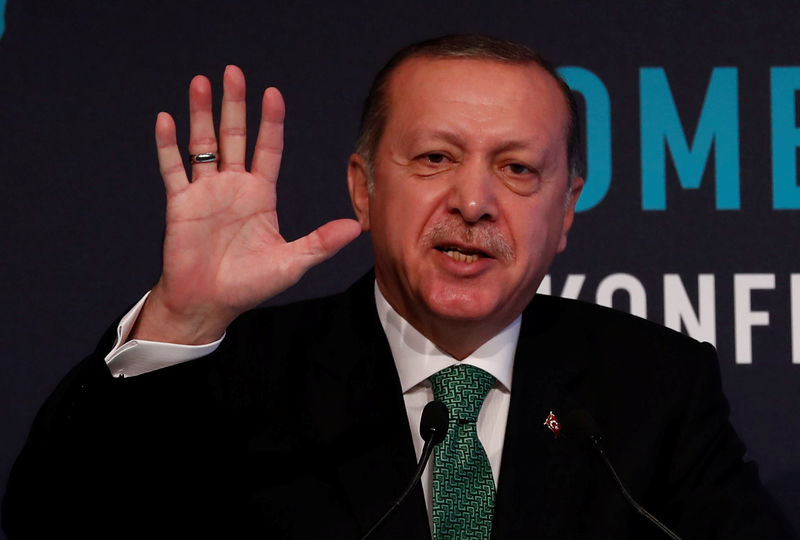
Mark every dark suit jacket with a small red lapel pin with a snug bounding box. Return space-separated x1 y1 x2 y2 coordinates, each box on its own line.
3 276 791 539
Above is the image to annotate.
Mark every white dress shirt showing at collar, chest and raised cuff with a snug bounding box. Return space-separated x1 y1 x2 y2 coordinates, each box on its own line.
105 282 522 520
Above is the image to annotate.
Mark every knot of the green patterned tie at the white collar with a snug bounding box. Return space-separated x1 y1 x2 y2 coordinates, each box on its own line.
429 364 495 422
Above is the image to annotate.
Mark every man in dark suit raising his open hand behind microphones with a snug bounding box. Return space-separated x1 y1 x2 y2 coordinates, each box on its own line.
4 36 790 538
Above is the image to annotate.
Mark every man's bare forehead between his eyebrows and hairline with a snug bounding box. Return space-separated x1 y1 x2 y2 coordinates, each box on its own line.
384 57 569 148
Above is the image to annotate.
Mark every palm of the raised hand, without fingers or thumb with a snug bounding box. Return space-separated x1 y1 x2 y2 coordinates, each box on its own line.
164 167 284 311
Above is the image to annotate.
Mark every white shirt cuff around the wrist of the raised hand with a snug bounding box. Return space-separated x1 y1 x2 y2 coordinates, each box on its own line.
105 291 225 377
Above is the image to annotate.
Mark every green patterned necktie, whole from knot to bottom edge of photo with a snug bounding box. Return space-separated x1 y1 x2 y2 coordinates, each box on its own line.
430 364 495 540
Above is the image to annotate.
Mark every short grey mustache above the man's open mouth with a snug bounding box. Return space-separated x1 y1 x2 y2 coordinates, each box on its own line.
422 216 515 262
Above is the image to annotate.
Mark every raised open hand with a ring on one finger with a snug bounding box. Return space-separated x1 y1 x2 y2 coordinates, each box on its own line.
132 66 361 344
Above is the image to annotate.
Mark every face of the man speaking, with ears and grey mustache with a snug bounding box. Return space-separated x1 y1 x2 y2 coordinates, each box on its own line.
349 58 583 352
